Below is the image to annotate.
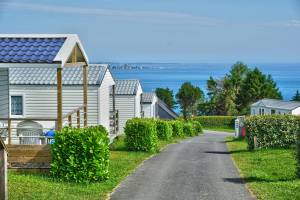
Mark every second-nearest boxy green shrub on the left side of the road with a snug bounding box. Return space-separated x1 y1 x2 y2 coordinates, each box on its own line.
124 118 158 152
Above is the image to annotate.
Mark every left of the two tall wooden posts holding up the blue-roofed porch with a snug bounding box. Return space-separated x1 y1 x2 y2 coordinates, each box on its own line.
56 68 63 131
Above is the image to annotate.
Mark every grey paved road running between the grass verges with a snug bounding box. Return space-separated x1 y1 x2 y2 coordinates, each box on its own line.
111 131 253 200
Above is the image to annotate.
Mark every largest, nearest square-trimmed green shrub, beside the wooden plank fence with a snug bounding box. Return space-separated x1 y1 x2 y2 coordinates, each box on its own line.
51 126 109 182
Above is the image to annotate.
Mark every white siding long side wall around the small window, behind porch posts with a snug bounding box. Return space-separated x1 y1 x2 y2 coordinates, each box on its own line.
10 85 98 142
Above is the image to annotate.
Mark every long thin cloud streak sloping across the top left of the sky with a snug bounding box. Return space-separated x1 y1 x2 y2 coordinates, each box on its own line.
0 2 219 26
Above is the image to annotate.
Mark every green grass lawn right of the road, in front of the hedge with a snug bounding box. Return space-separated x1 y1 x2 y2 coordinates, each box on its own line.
227 137 300 200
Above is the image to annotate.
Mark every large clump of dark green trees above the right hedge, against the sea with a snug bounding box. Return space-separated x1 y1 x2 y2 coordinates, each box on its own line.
198 62 282 115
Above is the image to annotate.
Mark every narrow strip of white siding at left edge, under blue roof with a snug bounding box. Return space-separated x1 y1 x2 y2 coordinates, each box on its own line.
0 69 9 118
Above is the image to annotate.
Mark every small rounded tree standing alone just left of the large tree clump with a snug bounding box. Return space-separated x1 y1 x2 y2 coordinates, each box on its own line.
176 82 204 120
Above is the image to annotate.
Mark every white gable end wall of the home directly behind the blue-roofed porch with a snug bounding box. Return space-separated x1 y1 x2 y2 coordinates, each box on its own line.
98 71 115 132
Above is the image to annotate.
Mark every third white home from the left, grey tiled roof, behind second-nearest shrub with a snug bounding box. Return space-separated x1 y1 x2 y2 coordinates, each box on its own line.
110 80 143 133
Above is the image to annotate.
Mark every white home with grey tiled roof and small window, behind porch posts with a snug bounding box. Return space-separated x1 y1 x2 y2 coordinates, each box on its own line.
9 65 115 135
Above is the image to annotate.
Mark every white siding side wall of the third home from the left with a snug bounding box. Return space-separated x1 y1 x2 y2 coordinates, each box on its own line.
110 95 138 134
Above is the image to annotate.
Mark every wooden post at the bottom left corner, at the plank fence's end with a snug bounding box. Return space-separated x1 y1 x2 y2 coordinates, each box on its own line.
0 138 8 200
